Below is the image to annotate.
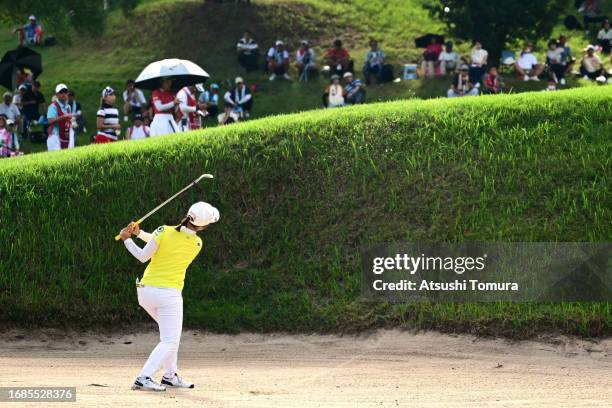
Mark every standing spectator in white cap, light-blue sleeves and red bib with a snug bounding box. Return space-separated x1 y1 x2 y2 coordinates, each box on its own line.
47 84 74 151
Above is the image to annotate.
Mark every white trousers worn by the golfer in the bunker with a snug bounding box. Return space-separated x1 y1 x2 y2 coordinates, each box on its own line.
138 286 183 378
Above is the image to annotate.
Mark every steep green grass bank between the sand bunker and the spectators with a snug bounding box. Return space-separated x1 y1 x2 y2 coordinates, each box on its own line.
0 86 612 337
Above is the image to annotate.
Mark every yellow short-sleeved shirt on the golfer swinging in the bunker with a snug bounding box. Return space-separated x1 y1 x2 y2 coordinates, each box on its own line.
141 225 202 290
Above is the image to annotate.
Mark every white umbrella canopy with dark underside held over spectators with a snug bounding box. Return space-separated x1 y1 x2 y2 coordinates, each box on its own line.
136 58 209 90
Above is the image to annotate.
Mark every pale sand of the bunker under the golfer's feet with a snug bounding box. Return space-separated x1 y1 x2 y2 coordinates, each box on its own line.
0 331 612 408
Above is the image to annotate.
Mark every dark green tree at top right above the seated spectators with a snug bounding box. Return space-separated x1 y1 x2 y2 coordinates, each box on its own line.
426 0 568 63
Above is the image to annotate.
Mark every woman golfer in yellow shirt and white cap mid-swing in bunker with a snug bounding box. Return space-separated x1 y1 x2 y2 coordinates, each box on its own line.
120 202 219 391
